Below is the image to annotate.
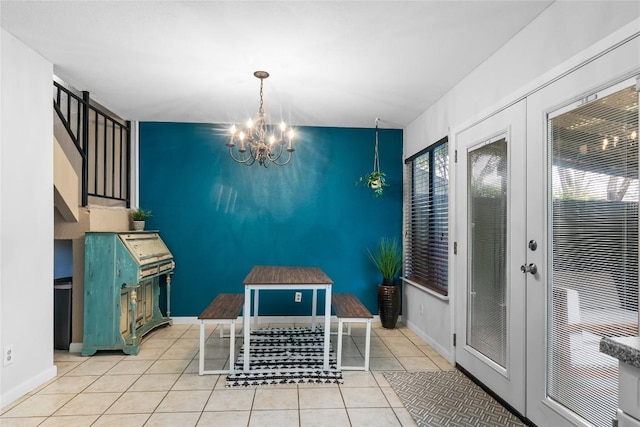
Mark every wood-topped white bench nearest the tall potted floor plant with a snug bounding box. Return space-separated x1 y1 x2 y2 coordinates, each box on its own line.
331 293 373 371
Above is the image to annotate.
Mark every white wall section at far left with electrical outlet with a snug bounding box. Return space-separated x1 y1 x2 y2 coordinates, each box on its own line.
0 29 56 407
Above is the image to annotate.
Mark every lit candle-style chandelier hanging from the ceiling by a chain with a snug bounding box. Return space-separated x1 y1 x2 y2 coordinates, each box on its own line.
226 71 295 168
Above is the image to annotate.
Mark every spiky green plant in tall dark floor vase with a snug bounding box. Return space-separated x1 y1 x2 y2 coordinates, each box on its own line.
367 237 402 329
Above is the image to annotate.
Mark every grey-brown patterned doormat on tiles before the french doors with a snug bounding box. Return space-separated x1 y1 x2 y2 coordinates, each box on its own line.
384 371 525 427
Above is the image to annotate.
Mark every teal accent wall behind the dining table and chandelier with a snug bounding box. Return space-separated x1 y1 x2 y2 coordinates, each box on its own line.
140 122 403 316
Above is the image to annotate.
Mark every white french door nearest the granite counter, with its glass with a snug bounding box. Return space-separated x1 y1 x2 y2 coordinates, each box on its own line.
526 75 640 426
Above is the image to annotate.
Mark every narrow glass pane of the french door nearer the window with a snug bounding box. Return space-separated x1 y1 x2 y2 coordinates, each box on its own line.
467 138 508 367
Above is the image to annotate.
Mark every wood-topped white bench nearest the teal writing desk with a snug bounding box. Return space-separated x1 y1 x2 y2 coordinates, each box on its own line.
198 294 244 375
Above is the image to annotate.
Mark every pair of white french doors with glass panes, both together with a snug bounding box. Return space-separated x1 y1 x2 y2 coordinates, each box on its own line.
453 31 640 427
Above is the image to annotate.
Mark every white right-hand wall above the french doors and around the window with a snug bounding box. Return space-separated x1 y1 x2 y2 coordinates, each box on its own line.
403 1 640 360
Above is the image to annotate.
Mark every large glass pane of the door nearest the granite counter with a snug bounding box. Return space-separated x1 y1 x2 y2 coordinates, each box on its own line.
547 87 638 426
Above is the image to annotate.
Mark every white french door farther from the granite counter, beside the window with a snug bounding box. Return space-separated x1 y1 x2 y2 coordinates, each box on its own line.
455 101 524 412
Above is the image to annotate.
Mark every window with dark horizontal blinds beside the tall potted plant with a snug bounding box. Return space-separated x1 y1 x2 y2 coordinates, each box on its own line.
404 137 449 295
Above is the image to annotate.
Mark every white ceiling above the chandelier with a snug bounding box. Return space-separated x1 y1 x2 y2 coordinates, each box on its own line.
0 0 551 127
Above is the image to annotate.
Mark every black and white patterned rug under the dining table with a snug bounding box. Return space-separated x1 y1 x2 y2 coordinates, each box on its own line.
226 328 343 387
